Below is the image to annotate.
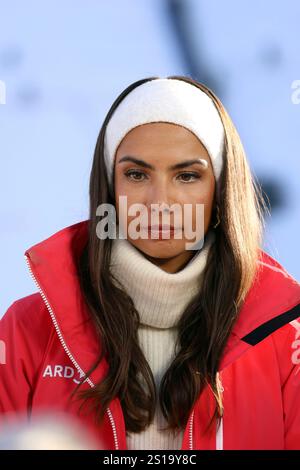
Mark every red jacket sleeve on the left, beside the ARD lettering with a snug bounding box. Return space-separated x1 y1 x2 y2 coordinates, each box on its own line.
0 293 51 427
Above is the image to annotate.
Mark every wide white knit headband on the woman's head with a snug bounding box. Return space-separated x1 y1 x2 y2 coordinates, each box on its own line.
104 78 224 189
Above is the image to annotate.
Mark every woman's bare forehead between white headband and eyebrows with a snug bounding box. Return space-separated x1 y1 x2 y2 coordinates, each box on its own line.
116 122 210 161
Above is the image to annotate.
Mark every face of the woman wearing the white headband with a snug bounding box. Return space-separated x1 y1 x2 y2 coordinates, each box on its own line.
114 122 215 271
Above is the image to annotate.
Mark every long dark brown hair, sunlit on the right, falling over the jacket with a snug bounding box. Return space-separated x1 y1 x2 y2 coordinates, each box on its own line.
72 76 265 433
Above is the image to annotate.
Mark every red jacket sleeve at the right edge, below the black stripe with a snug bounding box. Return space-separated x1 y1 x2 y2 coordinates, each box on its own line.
275 317 300 450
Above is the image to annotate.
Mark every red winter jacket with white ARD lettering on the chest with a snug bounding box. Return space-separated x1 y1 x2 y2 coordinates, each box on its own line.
0 221 300 450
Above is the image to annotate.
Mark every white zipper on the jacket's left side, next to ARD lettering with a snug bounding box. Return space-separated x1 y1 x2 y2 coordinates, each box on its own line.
24 255 119 450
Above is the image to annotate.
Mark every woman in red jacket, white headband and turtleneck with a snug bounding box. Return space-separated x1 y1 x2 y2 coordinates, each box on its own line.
0 76 300 449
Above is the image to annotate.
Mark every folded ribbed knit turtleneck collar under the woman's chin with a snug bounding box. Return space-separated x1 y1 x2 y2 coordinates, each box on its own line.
110 230 215 328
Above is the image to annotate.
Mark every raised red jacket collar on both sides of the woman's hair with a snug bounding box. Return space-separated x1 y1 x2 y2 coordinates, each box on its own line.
25 220 300 383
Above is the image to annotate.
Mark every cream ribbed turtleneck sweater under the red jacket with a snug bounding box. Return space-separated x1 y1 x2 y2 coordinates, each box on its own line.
110 230 215 450
